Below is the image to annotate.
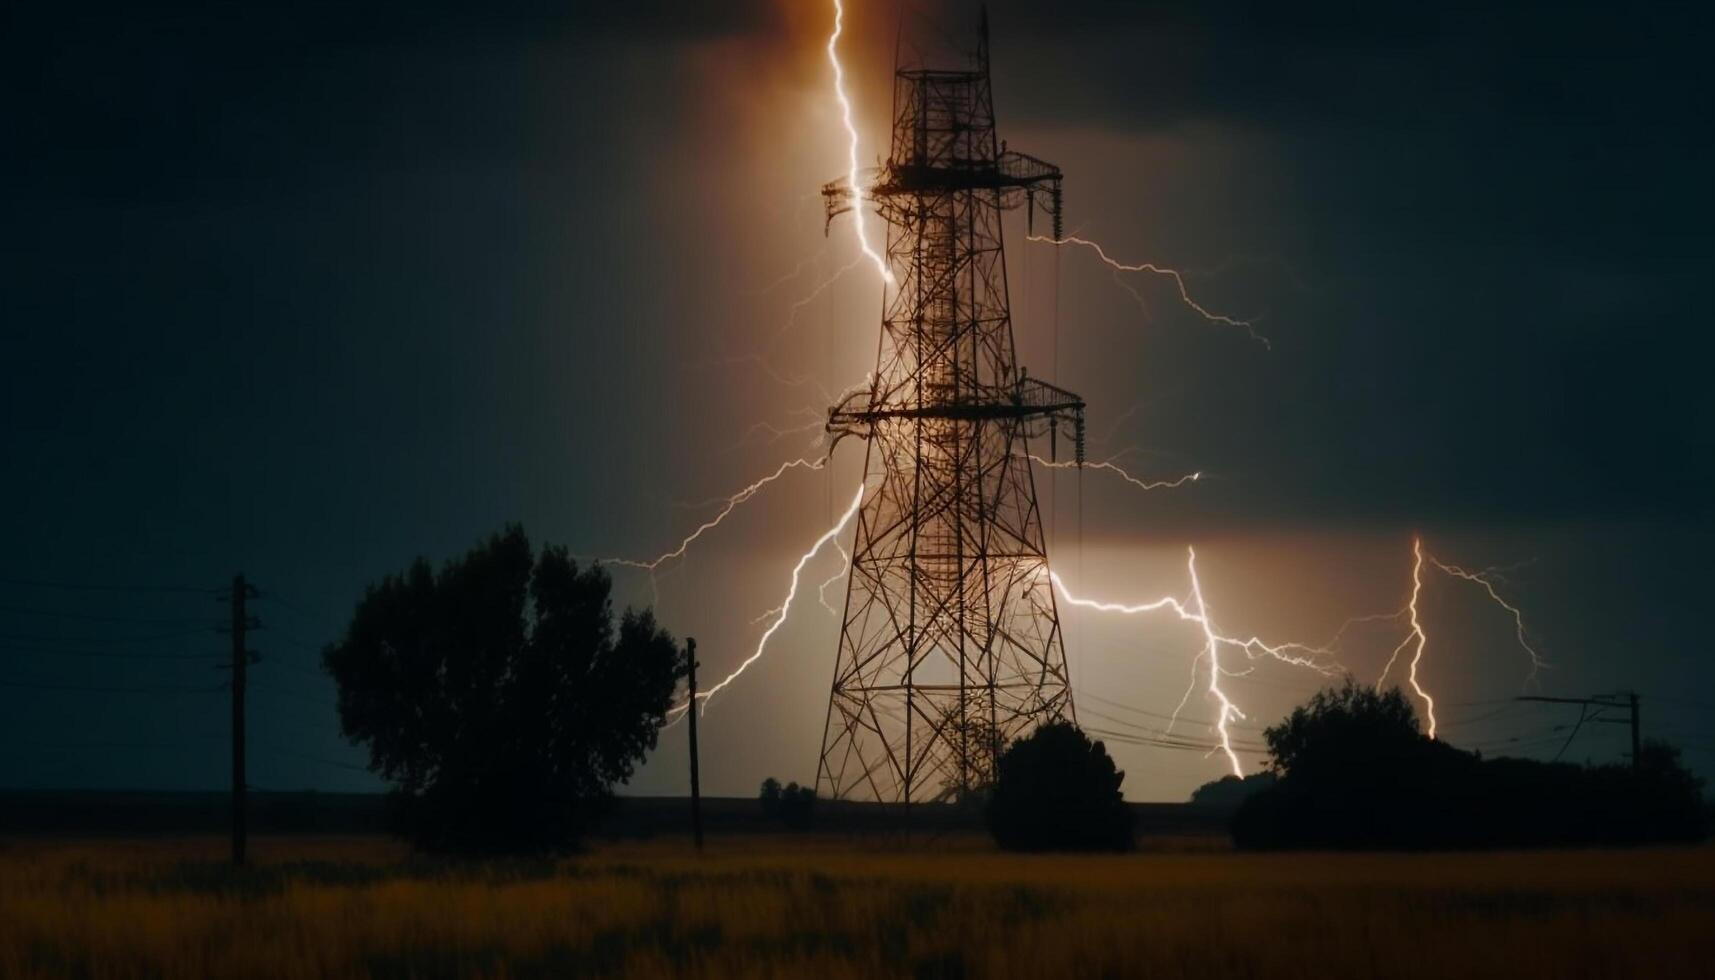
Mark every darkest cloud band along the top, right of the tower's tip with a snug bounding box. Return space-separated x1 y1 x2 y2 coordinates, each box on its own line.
980 2 1712 132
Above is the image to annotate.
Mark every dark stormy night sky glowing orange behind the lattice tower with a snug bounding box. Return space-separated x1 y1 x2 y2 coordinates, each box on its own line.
0 0 1715 800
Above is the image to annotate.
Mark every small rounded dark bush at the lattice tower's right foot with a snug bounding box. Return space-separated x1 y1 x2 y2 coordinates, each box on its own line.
988 721 1132 851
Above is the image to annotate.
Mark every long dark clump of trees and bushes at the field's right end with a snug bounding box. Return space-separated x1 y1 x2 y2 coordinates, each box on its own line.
1231 678 1703 848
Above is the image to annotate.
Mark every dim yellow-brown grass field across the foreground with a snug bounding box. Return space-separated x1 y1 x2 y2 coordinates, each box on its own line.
0 838 1715 980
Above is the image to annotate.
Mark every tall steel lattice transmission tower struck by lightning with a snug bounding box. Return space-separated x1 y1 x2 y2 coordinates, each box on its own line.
816 15 1084 803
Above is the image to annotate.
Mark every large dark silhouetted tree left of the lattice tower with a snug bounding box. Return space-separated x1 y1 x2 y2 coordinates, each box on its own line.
322 525 684 851
